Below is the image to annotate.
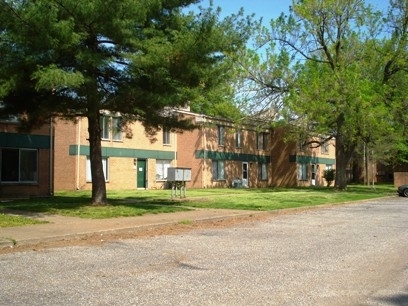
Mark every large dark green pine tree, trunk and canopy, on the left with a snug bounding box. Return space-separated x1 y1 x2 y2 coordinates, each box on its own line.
0 0 255 204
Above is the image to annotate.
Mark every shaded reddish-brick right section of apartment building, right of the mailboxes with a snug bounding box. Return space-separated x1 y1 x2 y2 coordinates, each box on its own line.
177 109 335 188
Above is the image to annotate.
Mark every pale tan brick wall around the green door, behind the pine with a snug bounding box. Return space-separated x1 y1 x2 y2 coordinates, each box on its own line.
54 118 177 190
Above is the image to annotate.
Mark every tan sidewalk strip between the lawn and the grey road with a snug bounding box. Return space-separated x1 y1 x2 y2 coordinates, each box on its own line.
0 209 261 248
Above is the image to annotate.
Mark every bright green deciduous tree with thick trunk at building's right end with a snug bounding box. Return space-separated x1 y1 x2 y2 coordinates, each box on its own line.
236 0 392 189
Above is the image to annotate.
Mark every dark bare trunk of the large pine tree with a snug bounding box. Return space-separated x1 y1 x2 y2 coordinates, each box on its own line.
88 112 108 205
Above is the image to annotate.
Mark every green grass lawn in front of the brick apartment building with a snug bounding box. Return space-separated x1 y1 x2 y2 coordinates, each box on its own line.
0 185 396 227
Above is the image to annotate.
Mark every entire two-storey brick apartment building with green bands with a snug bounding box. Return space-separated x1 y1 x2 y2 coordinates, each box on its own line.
0 109 335 196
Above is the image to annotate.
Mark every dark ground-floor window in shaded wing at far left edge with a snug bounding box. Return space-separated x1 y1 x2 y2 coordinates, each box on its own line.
1 149 38 183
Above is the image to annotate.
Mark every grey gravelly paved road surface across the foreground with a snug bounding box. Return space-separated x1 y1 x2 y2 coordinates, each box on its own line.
0 197 408 305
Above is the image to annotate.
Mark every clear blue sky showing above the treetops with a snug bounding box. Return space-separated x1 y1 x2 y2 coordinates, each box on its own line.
200 0 388 23
